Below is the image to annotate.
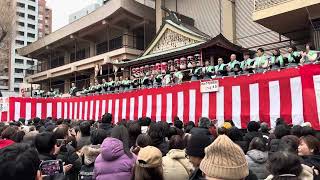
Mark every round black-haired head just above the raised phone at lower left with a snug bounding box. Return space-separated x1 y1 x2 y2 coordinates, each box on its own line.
34 132 57 154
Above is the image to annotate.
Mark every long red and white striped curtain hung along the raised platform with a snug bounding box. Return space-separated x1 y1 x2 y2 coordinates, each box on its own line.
3 65 320 129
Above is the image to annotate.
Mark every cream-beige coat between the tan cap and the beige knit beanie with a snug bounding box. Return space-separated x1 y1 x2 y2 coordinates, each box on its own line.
162 149 193 180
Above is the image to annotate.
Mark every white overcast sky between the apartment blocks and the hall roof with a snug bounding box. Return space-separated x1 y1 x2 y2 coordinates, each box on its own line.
47 0 96 31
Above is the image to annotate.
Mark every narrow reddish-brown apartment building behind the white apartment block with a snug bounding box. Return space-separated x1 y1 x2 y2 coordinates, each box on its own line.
38 0 52 38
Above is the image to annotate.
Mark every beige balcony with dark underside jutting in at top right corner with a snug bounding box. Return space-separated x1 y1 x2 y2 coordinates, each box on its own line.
252 0 320 39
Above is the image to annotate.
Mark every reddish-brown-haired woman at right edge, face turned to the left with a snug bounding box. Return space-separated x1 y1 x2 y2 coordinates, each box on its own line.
298 135 320 172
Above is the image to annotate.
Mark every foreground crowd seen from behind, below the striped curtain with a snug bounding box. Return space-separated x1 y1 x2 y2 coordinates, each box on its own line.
0 113 320 180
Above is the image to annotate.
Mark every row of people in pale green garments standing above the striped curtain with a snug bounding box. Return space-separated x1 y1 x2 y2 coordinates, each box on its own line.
36 44 320 97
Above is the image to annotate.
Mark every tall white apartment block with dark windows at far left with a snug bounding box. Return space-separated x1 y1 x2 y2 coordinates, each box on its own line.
8 0 39 93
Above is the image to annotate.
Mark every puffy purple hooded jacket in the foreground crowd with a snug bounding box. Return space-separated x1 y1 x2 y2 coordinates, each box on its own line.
94 138 136 180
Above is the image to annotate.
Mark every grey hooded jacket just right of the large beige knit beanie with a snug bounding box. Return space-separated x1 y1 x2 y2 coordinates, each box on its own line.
246 149 269 179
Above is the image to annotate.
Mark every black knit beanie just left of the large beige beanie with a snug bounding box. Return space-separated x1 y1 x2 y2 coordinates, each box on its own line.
186 134 211 158
